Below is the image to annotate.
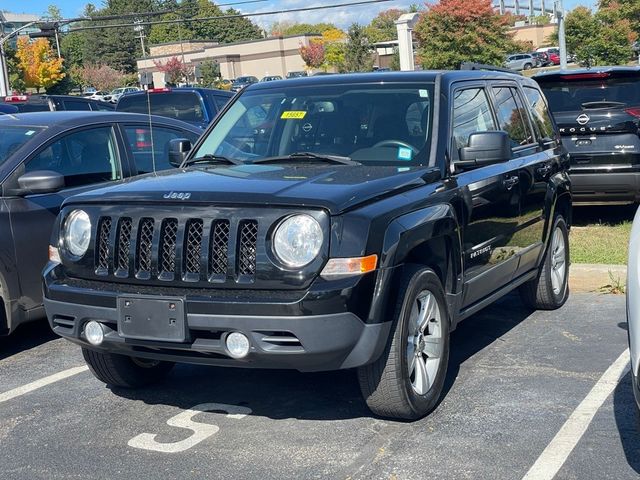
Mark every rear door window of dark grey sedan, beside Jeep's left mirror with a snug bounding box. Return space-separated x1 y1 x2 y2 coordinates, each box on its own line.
123 124 198 173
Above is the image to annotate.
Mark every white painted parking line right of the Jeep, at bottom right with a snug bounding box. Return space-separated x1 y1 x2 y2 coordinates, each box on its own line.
523 349 629 480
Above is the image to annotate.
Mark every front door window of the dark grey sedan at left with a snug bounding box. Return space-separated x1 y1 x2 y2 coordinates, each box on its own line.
25 127 122 187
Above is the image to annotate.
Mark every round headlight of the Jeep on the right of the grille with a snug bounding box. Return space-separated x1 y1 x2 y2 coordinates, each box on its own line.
273 215 323 268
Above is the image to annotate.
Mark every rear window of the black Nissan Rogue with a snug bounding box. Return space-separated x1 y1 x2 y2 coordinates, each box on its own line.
540 78 640 112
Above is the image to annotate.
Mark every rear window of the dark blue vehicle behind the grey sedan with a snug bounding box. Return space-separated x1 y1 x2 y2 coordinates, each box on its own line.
116 92 206 122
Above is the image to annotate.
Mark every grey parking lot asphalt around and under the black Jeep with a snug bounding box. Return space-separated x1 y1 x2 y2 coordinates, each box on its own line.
0 293 640 480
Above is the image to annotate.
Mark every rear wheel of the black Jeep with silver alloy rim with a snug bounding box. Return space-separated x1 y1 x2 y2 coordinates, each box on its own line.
520 215 570 310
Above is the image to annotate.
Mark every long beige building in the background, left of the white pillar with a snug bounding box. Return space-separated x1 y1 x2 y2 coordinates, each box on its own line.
137 35 315 87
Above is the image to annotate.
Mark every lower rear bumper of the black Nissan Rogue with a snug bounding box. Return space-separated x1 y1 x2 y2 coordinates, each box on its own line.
570 170 640 203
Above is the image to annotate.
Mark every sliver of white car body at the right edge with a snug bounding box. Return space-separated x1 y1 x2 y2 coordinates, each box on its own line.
627 209 640 409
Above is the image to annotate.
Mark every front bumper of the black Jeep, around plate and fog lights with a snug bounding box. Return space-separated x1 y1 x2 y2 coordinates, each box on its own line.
44 267 391 372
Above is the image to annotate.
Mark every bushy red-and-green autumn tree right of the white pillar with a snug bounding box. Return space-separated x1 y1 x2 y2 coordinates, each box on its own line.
414 0 519 69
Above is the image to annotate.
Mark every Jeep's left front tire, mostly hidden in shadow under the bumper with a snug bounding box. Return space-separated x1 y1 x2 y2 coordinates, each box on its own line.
82 348 174 388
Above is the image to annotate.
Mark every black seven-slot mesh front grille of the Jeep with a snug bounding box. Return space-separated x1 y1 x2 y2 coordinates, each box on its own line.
95 216 258 283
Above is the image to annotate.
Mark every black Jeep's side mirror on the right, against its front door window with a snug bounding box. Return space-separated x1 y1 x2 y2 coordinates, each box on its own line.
456 130 513 168
